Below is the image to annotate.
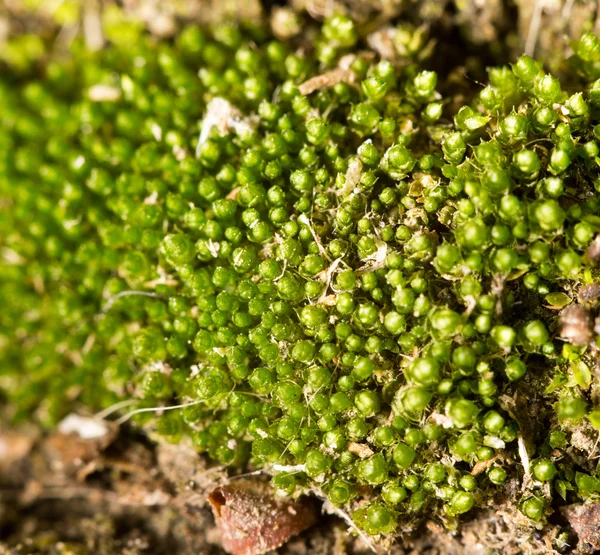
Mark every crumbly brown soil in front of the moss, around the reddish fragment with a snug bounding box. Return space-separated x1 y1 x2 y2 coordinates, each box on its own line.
0 427 576 555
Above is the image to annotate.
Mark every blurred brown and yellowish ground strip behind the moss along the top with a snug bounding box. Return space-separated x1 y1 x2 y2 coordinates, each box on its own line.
0 0 600 74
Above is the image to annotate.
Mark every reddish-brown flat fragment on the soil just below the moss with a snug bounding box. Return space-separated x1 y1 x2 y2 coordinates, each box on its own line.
208 479 318 555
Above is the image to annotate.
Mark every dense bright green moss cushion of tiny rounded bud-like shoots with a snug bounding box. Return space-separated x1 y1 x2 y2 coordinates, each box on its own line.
0 16 600 535
